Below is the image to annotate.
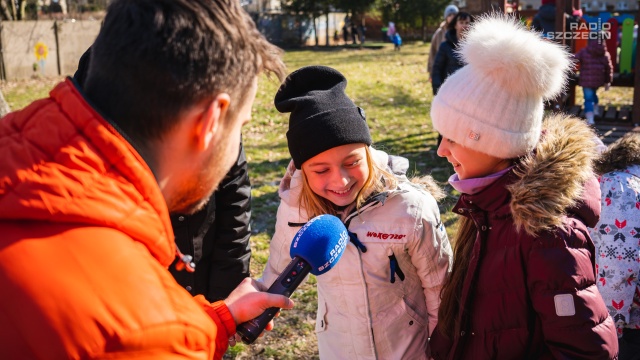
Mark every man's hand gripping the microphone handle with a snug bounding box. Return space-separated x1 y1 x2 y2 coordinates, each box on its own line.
224 278 294 324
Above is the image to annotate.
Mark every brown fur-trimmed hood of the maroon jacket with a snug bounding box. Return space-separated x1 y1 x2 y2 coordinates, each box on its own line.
508 114 600 235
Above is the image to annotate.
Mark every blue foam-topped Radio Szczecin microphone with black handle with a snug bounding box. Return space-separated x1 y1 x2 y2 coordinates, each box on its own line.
236 214 349 344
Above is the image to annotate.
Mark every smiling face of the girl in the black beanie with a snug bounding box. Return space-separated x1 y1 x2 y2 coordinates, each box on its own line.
302 144 370 206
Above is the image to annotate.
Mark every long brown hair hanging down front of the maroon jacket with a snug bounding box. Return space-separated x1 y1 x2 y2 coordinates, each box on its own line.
438 216 477 339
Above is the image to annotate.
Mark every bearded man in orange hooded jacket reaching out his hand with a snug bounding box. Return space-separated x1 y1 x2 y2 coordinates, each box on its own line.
0 0 293 359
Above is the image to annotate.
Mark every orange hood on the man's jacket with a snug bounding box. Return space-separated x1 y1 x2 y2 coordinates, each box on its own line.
0 79 175 266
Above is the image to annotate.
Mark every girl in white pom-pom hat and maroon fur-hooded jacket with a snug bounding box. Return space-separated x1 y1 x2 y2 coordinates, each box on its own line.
430 14 618 359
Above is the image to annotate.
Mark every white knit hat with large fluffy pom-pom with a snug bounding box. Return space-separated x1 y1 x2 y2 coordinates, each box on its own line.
431 13 571 159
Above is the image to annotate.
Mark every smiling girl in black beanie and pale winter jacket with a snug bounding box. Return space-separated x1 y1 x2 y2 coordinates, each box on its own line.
262 66 451 360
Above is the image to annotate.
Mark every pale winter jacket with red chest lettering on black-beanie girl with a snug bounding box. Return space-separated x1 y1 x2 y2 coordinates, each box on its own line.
262 149 452 360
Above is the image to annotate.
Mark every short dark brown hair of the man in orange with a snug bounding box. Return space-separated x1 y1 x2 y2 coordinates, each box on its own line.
84 0 285 146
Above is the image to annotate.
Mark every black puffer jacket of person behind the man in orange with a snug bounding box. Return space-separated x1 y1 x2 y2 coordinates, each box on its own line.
169 142 251 301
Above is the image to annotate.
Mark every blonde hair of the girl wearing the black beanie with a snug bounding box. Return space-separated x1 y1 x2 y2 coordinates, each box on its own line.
299 146 398 219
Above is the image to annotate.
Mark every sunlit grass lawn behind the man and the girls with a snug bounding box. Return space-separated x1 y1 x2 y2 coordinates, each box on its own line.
0 42 632 359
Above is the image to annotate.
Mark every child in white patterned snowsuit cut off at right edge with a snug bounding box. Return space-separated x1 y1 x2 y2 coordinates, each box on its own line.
591 132 640 360
